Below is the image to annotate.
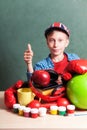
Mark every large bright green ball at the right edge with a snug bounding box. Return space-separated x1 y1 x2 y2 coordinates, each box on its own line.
66 73 87 109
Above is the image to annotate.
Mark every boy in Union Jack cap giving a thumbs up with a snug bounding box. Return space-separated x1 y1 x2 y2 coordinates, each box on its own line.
24 22 79 80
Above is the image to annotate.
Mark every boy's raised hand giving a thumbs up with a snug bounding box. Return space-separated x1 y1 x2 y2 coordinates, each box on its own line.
24 44 33 64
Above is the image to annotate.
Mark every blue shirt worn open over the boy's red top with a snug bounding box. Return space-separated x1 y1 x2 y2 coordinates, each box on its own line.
27 53 80 80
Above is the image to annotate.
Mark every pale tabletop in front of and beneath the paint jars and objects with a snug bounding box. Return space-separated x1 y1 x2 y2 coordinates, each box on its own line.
0 91 87 130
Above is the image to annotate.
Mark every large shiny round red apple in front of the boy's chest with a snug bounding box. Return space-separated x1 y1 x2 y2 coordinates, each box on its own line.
32 70 50 87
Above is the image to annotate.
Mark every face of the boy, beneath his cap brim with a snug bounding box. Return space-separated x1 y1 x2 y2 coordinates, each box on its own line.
46 31 69 56
